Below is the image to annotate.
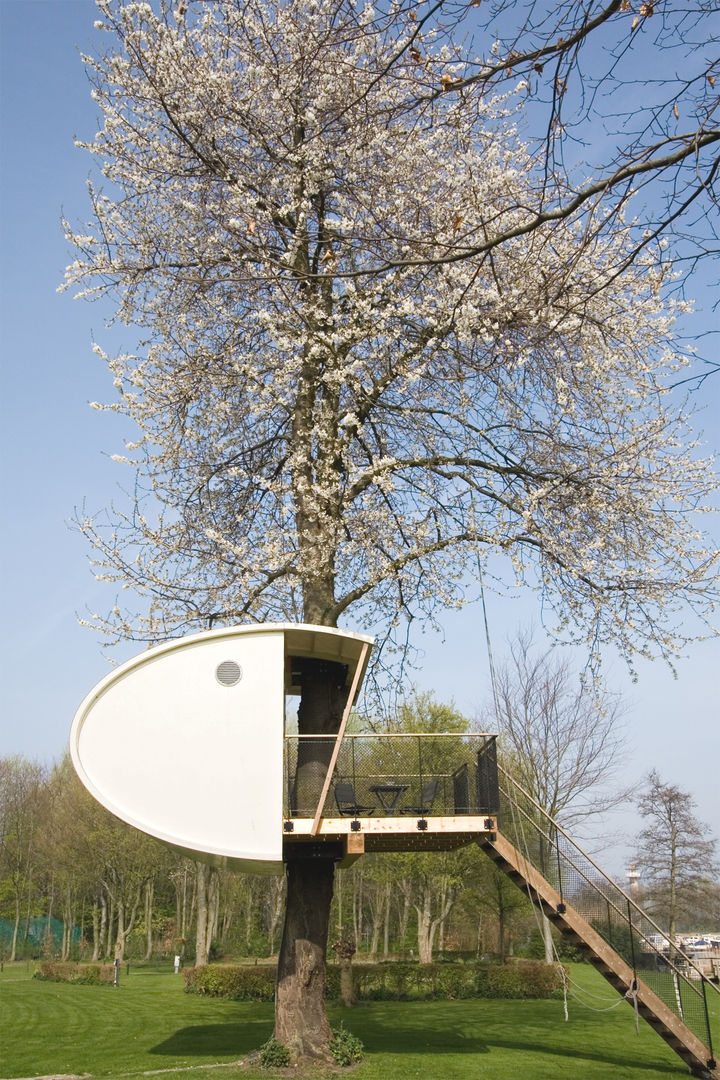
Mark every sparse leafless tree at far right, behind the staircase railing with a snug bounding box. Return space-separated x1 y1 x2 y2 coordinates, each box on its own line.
635 769 719 940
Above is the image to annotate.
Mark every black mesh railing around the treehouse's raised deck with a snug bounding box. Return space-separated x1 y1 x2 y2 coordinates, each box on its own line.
285 733 499 818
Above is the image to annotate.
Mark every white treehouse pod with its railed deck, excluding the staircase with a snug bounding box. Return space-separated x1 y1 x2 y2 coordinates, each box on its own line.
70 623 498 873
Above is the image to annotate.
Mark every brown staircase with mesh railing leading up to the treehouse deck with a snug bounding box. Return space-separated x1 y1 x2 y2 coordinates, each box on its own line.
477 766 720 1080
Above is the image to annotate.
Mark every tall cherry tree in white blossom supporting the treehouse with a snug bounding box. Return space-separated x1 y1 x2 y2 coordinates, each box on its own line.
68 0 717 1057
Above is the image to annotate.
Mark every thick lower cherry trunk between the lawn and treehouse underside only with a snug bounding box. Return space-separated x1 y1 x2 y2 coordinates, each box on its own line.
275 858 335 1063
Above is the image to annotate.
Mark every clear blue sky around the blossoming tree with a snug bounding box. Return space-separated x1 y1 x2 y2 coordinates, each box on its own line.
0 0 720 868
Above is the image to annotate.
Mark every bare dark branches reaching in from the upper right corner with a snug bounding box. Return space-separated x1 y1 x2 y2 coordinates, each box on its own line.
384 0 720 311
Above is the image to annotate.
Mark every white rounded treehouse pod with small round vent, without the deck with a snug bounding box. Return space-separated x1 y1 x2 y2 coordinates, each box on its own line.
70 623 371 872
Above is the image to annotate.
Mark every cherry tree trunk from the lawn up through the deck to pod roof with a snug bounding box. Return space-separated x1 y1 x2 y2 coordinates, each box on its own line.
275 659 348 1063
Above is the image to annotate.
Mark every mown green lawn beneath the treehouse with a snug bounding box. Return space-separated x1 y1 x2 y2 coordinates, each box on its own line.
0 964 717 1080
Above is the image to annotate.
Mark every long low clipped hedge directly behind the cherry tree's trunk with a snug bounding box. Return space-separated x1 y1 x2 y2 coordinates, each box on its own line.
182 960 562 1001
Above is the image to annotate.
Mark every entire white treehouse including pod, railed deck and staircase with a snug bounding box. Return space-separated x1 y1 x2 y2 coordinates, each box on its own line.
70 623 720 1080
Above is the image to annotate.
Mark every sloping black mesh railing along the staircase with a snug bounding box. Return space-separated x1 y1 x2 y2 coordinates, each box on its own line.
499 767 718 1053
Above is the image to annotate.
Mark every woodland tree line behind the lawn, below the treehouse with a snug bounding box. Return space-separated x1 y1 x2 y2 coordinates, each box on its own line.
0 757 546 963
